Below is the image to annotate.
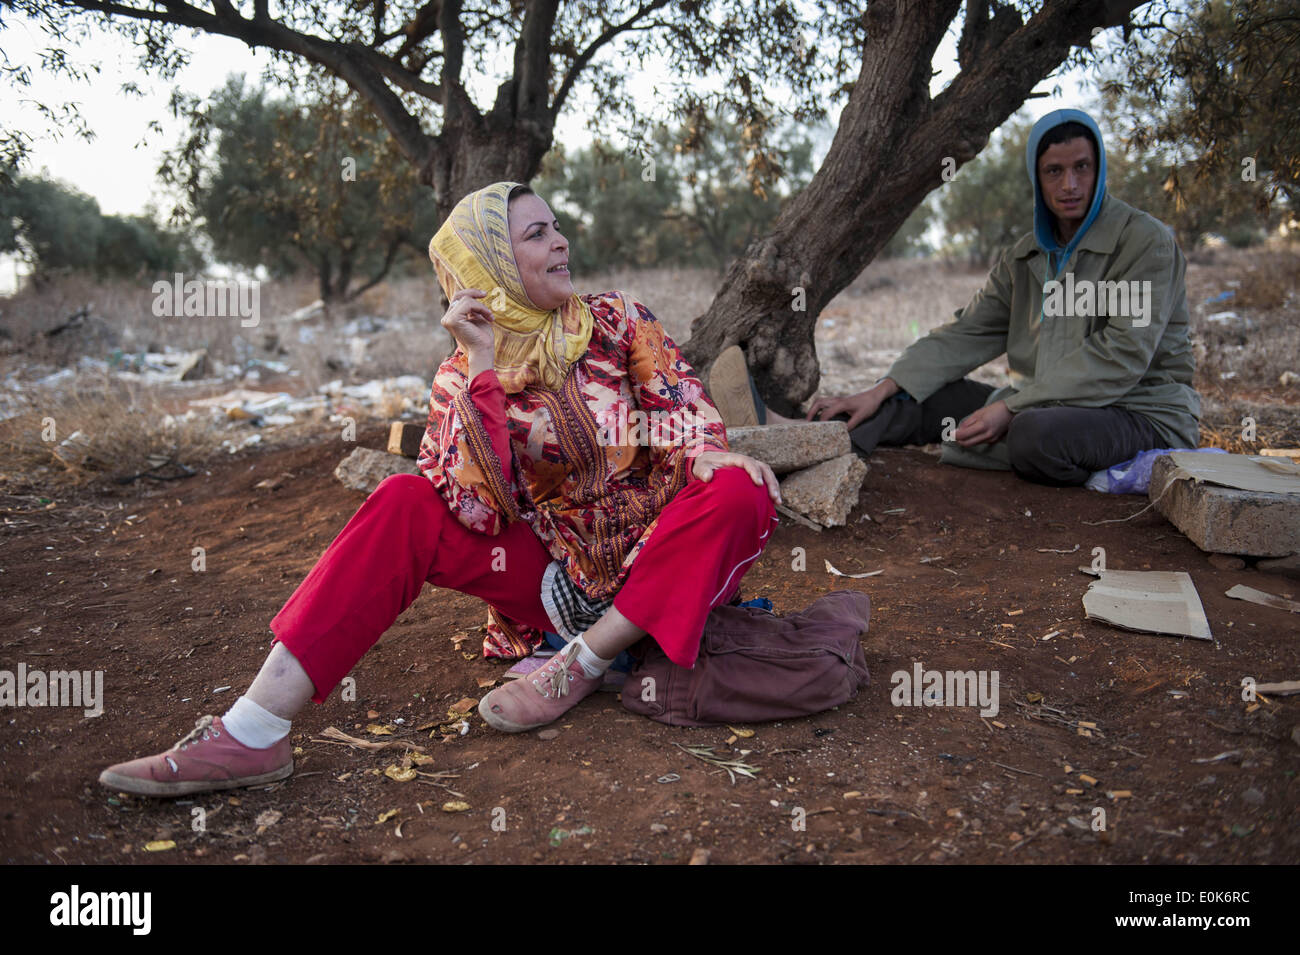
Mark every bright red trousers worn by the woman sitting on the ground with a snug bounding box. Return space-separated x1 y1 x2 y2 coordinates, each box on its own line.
270 468 776 703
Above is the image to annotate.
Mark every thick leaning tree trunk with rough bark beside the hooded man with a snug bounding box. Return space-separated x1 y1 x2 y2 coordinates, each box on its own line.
684 0 1139 414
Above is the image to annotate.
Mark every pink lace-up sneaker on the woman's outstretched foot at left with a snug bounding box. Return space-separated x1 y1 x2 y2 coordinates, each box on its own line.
99 716 294 796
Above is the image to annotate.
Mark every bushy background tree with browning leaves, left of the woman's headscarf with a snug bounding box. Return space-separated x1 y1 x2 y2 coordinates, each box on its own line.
164 78 438 301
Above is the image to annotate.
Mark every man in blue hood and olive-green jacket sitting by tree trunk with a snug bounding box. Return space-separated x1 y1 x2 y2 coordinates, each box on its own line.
807 109 1200 485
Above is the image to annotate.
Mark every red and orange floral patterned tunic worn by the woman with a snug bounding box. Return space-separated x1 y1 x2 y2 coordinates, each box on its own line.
417 291 727 657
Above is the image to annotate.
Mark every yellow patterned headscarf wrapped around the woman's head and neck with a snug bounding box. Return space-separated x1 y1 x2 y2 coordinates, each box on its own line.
429 182 592 394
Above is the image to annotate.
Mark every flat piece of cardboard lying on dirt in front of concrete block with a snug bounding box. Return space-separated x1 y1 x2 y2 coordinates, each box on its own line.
1083 570 1213 641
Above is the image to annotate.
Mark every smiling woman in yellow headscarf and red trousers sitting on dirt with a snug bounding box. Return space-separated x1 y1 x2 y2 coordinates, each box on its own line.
100 182 779 795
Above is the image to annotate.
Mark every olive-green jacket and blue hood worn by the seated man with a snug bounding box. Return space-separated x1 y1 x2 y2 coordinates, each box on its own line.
887 109 1200 468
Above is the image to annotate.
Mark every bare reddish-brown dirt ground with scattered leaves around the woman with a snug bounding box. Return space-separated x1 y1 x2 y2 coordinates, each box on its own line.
0 431 1300 863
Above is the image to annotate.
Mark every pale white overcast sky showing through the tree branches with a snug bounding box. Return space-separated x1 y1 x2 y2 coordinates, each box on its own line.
0 14 1097 222
